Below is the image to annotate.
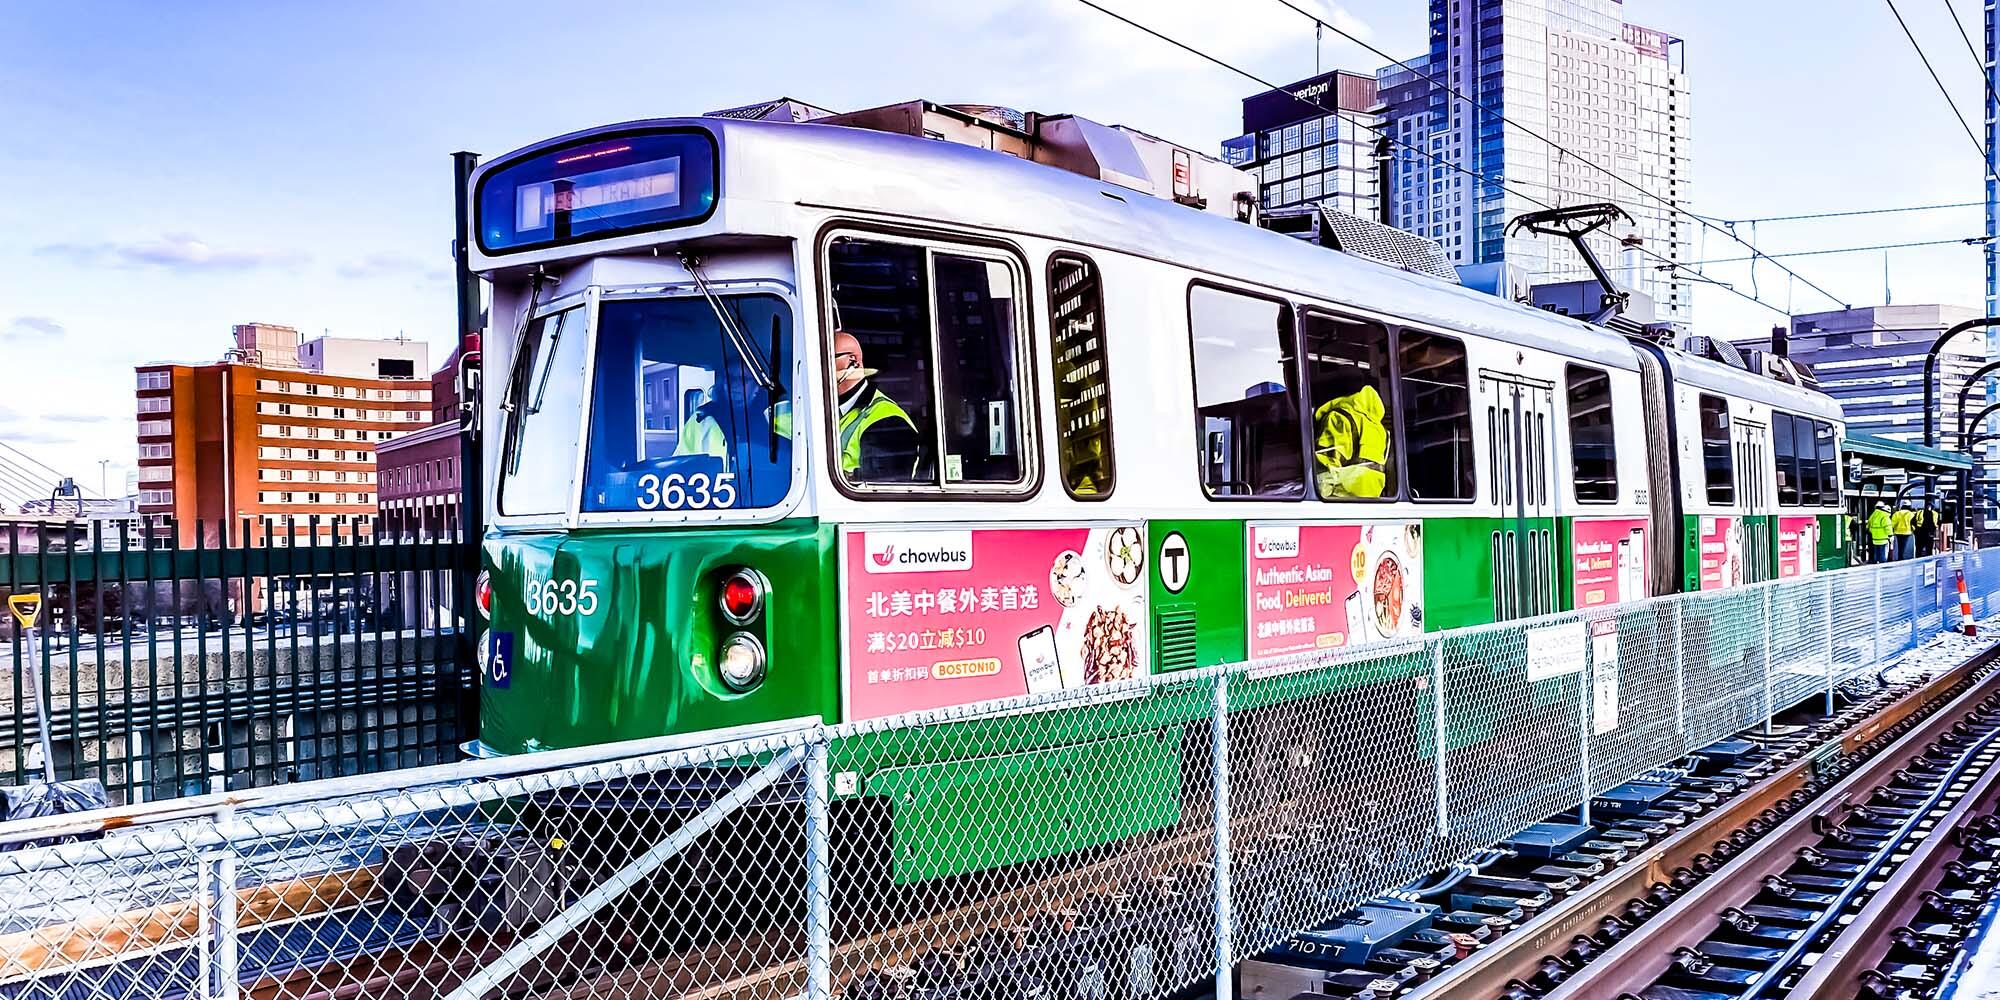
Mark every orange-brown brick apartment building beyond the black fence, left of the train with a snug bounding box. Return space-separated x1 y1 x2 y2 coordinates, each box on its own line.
136 324 432 544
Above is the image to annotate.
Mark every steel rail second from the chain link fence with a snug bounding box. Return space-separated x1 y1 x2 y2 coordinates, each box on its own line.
1536 648 2000 1000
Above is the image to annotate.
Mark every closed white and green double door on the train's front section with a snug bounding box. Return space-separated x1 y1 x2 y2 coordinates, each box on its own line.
1480 372 1556 620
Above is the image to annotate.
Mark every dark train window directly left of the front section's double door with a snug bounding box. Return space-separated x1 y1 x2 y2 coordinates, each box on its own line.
1392 330 1474 502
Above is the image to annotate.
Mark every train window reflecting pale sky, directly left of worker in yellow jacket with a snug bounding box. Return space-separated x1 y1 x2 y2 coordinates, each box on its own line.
1188 286 1306 500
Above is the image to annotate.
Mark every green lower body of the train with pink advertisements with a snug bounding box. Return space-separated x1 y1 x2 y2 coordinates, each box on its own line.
480 516 1846 882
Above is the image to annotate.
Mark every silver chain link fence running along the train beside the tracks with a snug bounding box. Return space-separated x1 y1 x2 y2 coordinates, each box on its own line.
0 552 2000 1000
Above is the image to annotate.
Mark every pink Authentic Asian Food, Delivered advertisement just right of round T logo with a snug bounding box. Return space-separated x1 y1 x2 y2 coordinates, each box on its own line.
1246 522 1424 660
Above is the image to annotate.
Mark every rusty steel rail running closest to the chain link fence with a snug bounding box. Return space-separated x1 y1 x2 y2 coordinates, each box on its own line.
1408 646 2000 1000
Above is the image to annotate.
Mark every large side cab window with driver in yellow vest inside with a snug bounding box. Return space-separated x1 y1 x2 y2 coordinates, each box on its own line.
826 236 1028 492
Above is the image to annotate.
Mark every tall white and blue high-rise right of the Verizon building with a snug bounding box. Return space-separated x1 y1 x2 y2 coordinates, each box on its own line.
1378 0 1698 322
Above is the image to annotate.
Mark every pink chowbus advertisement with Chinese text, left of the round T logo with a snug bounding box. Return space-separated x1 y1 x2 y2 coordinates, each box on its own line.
842 524 1148 720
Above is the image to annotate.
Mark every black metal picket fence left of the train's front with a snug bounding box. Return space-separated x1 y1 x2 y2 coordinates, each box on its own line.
0 518 478 802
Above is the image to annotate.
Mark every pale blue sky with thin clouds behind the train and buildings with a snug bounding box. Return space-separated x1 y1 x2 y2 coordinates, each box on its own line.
0 0 1984 492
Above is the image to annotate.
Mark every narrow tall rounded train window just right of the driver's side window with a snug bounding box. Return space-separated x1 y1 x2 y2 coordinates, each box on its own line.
1048 254 1116 500
